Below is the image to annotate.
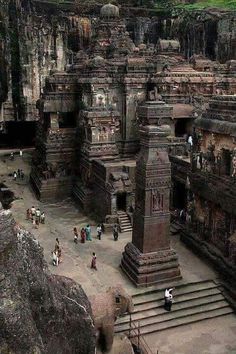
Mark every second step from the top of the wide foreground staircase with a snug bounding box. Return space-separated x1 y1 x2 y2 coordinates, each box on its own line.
116 293 227 325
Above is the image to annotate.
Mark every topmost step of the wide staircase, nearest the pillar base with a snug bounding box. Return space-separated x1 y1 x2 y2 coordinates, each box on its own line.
132 280 217 305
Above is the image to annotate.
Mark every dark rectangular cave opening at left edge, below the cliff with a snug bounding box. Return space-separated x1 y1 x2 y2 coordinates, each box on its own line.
0 122 37 148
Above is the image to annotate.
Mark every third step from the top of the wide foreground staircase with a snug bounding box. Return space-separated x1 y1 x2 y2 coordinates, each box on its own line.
115 300 233 333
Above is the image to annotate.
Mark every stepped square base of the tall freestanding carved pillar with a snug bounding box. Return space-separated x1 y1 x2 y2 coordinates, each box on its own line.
121 242 182 287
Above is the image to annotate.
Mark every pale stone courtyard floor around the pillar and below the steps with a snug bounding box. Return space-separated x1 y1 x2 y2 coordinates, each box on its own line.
0 153 236 354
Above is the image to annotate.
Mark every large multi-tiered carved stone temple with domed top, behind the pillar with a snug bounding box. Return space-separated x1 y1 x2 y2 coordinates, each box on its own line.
26 4 236 284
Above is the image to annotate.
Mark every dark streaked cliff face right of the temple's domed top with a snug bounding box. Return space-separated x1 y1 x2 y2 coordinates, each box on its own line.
126 9 236 63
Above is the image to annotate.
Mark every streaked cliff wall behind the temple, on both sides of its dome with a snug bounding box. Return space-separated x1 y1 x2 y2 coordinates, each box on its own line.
0 0 236 125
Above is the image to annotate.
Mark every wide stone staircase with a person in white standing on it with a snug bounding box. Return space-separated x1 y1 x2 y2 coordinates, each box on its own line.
115 280 233 337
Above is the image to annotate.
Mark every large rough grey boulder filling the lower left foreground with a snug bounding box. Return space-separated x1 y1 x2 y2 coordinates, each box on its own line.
0 203 95 354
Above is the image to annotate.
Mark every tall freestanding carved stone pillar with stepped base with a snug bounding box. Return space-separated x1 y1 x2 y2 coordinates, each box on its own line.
121 102 181 286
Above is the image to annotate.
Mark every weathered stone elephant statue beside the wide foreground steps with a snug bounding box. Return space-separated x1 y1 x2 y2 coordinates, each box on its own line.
89 286 133 351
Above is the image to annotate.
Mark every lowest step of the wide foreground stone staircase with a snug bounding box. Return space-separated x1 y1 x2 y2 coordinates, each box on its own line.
130 307 233 337
